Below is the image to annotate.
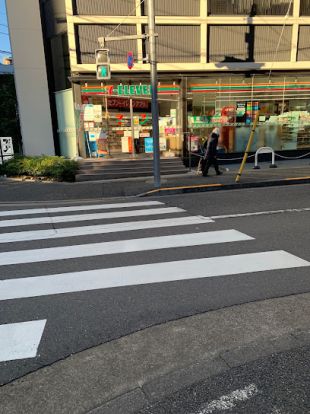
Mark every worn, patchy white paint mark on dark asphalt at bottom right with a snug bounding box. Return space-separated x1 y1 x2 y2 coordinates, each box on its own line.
196 384 258 414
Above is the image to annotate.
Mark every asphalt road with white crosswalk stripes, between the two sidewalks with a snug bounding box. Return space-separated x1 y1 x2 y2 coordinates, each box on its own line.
0 185 310 384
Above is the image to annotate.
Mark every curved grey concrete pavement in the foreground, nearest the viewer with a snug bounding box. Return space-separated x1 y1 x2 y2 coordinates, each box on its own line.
0 293 310 414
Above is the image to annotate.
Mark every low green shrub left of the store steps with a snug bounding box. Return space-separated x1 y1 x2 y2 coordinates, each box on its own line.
0 156 78 181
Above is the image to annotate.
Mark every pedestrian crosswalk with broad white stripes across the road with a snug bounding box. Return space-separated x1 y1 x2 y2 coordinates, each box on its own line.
0 201 310 368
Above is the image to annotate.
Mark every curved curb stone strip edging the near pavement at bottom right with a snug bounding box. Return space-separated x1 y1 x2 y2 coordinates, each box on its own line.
85 330 310 414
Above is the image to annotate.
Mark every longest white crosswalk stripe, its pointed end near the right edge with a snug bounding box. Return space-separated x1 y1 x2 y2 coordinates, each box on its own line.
0 250 310 300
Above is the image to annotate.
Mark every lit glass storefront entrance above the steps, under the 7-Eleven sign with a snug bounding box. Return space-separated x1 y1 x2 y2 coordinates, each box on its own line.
82 83 182 159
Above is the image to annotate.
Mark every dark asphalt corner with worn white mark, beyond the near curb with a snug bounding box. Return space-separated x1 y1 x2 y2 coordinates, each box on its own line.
139 348 310 414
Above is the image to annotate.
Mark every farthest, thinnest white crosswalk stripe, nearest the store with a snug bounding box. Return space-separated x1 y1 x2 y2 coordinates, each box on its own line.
0 201 164 217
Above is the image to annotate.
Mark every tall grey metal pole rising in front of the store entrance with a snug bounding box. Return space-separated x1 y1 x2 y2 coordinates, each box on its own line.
147 0 160 188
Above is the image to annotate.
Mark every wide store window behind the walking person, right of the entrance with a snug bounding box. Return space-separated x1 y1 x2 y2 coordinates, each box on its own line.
188 76 310 153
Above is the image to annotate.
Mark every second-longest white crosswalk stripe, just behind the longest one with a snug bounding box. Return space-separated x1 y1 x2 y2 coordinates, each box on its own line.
0 230 253 266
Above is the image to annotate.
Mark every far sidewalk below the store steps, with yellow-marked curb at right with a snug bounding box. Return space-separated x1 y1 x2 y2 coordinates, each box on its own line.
0 158 310 203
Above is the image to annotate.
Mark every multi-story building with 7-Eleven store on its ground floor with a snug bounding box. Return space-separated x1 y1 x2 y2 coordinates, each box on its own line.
7 0 310 157
